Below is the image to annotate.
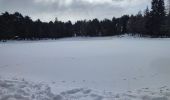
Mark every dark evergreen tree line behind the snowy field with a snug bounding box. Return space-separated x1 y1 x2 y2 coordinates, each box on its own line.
0 0 170 40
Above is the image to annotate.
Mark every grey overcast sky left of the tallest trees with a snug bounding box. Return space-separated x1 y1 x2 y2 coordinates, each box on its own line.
0 0 151 22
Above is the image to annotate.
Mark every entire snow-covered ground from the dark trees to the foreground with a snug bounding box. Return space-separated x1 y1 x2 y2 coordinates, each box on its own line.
0 37 170 100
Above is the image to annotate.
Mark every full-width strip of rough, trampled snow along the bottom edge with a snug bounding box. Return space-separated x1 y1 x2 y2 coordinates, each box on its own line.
0 79 170 100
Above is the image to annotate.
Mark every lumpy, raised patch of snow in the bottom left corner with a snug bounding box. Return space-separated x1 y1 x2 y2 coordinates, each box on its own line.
0 80 54 100
